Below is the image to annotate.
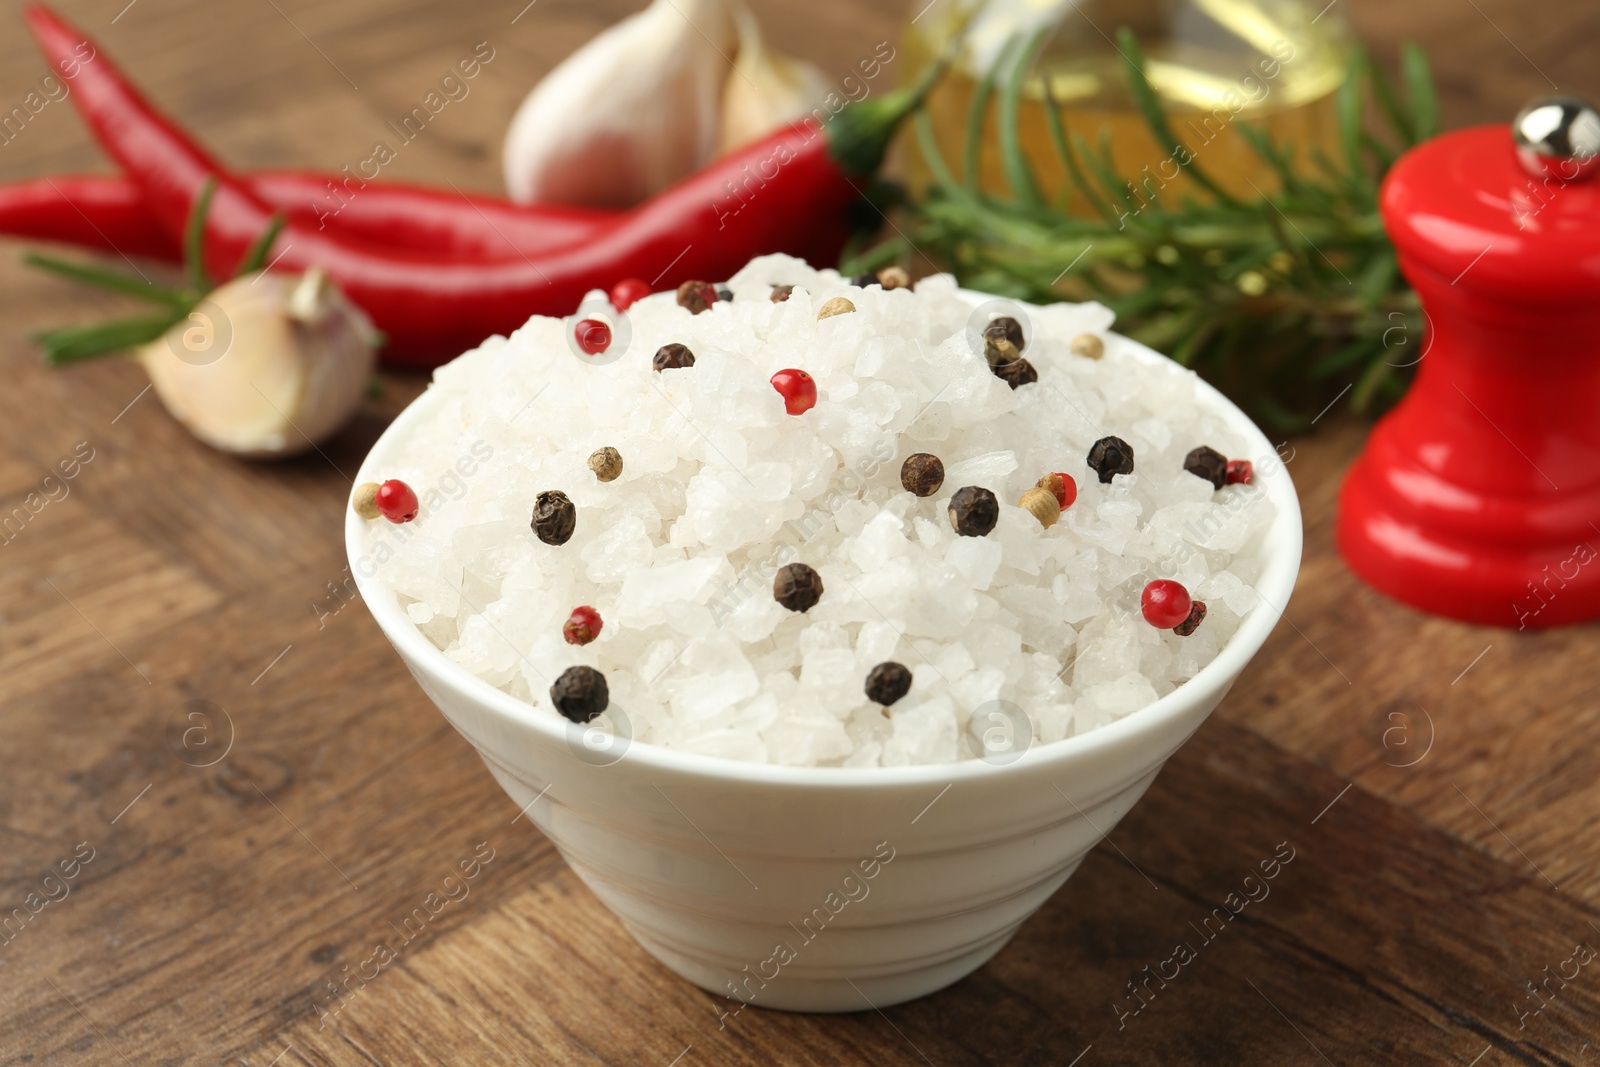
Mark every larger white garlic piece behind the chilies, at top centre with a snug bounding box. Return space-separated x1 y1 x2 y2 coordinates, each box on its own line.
504 0 738 206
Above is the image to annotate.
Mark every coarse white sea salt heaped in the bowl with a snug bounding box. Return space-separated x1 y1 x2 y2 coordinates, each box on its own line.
358 256 1274 766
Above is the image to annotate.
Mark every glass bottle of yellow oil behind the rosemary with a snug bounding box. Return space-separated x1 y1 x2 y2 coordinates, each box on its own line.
901 0 1350 211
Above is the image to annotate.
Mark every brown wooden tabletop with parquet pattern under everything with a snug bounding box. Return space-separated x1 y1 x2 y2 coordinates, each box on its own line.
0 0 1600 1067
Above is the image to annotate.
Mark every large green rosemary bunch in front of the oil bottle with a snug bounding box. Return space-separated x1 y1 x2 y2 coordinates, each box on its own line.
870 29 1437 432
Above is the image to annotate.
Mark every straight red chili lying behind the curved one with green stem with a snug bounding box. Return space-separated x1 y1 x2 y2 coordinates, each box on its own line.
0 171 618 262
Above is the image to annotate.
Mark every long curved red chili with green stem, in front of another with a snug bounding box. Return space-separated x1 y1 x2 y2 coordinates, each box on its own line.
24 3 930 366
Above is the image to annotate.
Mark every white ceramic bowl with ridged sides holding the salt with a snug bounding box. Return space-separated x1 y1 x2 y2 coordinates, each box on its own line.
346 299 1301 1013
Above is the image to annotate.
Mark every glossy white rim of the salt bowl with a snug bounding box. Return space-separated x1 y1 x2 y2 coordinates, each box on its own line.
344 288 1304 787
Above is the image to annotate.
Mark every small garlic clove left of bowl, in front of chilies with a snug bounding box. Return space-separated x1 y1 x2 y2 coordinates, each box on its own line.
138 267 378 458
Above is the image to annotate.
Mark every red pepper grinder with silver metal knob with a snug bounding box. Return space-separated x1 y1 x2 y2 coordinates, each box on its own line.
1338 98 1600 629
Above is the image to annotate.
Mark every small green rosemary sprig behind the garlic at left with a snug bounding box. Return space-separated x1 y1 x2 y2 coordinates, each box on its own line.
22 178 286 366
